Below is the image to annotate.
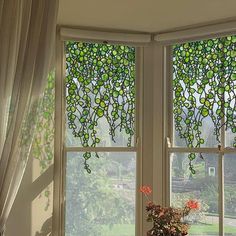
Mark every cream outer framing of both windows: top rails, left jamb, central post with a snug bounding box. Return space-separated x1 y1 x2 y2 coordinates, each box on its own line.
53 21 236 236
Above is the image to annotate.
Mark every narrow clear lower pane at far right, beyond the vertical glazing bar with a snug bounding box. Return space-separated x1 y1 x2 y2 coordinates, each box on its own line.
224 154 236 236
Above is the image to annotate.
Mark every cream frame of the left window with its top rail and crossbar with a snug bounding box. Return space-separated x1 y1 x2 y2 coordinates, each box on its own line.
53 27 155 236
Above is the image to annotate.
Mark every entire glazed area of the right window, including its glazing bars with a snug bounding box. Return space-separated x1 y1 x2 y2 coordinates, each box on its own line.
171 36 236 236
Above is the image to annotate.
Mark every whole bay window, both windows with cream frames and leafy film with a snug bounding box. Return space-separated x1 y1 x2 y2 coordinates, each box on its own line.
54 25 236 236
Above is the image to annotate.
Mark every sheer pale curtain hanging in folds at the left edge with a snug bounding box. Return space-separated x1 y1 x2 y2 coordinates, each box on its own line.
0 0 58 235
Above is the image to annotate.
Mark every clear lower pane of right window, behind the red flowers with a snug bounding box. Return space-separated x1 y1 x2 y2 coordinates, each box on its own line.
171 153 219 236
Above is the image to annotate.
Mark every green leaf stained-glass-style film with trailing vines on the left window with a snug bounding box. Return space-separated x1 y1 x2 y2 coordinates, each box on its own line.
65 41 135 171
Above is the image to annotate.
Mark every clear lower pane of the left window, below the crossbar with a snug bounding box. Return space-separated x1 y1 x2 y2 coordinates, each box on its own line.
65 153 136 236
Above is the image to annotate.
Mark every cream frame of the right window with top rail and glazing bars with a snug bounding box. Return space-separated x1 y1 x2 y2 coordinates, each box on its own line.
157 22 236 235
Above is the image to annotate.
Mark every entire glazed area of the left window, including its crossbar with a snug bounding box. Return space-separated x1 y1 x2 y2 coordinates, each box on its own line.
65 41 136 236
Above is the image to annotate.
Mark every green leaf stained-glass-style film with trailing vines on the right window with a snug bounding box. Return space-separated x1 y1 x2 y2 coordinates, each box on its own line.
173 36 236 172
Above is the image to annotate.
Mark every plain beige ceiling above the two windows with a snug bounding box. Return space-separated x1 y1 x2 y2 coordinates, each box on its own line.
58 0 236 33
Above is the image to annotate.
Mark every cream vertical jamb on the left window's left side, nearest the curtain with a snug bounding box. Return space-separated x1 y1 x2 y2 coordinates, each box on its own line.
52 35 65 236
